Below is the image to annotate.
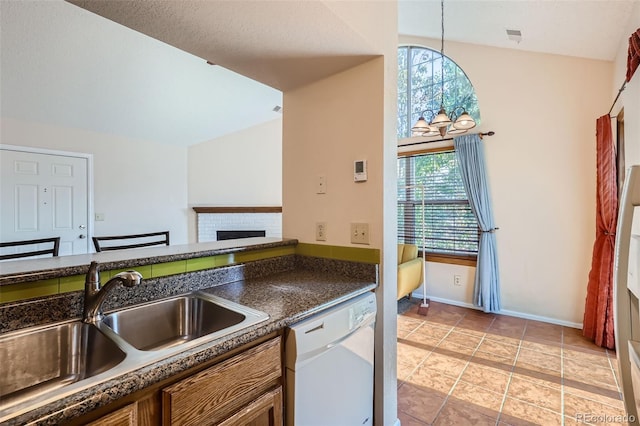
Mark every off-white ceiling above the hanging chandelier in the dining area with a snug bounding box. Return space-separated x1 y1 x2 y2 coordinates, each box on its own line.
398 0 640 61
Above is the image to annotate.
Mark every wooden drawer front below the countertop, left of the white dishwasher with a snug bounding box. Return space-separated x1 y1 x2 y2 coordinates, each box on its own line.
162 337 282 426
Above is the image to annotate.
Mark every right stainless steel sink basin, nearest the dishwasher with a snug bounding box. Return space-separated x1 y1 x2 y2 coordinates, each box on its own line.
102 294 266 351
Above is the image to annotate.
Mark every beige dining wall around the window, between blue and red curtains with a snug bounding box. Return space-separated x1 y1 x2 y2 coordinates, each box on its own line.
401 38 613 325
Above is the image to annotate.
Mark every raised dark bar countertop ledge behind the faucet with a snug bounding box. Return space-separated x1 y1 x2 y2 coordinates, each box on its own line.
0 237 298 286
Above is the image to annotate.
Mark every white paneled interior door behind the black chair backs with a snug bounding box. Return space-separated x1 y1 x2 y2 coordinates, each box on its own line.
0 149 89 256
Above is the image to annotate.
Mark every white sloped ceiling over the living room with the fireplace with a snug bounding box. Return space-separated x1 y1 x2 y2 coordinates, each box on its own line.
0 0 282 145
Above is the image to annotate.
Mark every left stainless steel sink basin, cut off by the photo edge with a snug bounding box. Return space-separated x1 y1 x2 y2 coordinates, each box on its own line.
0 321 125 405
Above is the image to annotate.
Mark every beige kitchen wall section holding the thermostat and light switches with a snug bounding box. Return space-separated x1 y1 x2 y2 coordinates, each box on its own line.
283 59 383 248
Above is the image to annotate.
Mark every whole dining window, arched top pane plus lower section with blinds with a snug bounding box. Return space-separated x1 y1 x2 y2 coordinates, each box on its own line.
398 46 480 264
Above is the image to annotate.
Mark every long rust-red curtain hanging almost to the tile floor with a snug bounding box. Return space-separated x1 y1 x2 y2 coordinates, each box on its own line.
582 114 618 349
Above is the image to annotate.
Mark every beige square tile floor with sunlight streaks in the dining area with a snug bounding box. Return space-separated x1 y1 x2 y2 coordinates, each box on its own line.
398 299 626 426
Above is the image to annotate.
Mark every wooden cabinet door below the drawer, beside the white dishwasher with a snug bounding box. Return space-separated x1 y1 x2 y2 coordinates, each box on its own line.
220 387 283 426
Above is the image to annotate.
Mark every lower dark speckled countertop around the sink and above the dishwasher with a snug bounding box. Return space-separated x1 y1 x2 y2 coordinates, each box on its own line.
0 268 376 425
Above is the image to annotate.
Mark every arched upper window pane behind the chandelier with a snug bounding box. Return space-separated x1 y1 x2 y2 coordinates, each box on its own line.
398 46 480 139
